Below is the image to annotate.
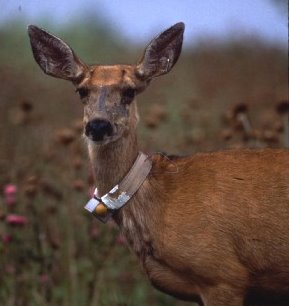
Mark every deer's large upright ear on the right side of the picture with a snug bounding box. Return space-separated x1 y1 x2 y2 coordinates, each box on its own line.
136 22 185 79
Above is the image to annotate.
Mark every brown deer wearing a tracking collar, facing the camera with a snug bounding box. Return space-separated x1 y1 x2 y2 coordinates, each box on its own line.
28 22 289 306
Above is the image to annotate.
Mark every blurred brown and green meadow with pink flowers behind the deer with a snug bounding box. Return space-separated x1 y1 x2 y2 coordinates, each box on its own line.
0 1 288 306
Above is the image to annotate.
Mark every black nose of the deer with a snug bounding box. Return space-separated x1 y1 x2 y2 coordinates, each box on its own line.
85 119 113 141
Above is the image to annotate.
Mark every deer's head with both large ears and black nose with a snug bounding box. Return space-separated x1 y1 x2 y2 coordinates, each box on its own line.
28 23 184 145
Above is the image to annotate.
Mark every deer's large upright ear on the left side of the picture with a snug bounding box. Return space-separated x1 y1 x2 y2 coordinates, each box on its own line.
28 25 87 82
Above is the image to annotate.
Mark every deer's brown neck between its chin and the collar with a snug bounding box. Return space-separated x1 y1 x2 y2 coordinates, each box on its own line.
88 131 138 195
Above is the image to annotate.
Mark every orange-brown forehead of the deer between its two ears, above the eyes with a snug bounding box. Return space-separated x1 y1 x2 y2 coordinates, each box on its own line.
85 65 137 88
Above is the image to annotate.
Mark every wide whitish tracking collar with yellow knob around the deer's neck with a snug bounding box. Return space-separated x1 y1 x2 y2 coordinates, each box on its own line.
84 152 152 223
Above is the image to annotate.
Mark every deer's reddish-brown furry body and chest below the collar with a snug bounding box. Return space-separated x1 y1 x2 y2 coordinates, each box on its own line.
101 142 289 305
